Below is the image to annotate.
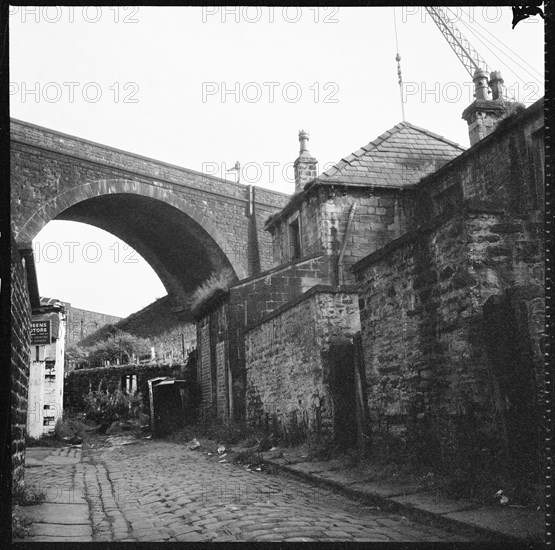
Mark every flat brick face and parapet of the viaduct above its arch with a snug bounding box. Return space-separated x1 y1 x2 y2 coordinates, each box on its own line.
10 121 288 276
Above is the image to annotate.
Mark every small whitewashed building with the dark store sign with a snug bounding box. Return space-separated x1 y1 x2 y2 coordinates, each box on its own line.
27 298 66 438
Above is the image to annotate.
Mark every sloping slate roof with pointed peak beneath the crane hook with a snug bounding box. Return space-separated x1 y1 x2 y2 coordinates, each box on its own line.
314 122 466 188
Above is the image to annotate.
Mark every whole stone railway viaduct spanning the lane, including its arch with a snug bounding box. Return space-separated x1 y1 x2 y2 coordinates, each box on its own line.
11 119 289 311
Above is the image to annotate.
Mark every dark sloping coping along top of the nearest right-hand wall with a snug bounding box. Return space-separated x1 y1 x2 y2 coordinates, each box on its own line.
350 199 516 274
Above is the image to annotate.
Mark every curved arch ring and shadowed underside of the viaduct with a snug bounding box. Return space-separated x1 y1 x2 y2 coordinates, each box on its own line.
16 179 248 305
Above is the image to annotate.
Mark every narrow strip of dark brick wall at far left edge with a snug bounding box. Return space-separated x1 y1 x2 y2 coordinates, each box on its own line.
11 239 31 490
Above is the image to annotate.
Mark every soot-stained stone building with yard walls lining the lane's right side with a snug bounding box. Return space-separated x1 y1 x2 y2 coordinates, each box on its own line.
196 79 543 470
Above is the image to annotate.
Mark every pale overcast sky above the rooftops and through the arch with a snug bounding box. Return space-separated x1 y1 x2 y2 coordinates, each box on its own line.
10 6 544 316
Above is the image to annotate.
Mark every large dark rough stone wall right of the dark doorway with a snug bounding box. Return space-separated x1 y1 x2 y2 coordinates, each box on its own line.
357 207 543 467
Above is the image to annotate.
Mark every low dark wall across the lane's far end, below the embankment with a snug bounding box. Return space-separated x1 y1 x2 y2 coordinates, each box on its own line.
64 363 191 410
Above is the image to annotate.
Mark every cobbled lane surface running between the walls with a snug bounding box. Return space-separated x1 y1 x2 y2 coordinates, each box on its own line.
16 437 474 542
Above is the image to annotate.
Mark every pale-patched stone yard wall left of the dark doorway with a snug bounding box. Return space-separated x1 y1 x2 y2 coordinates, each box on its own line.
245 287 359 441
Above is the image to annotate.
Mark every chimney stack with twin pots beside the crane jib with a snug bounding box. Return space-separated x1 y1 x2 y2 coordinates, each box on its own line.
462 69 524 146
